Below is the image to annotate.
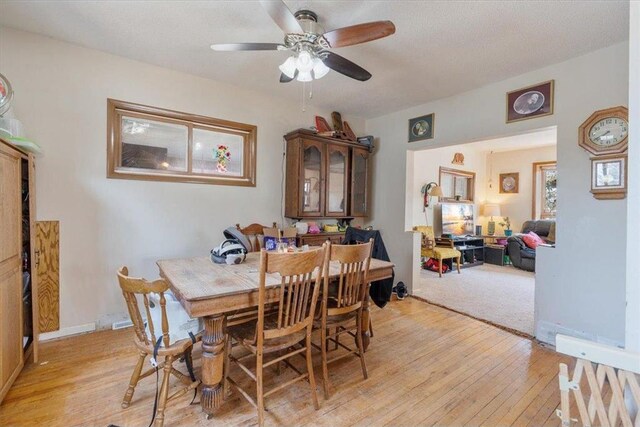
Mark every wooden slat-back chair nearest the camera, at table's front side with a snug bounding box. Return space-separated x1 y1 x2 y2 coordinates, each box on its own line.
225 243 328 426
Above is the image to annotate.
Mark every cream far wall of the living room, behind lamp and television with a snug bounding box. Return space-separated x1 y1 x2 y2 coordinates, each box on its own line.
483 146 556 234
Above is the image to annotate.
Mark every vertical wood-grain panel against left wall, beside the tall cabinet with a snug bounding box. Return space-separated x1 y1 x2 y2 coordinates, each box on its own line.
35 221 60 332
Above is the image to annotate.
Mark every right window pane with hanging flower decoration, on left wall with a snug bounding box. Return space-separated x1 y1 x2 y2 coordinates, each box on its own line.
191 128 244 176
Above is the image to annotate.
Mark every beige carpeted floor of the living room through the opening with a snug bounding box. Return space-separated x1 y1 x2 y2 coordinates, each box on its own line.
413 264 535 336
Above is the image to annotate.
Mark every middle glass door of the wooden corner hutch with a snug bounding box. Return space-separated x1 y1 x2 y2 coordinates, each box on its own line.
326 145 349 217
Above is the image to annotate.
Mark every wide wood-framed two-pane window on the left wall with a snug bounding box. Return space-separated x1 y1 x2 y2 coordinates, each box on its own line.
107 99 257 187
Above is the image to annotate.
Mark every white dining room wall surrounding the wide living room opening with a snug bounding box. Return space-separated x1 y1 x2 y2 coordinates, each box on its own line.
366 43 629 343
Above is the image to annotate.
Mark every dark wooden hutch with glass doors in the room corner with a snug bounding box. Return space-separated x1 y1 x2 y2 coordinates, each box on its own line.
285 129 370 219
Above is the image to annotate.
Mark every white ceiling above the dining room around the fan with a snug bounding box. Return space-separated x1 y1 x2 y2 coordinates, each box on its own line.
0 0 629 118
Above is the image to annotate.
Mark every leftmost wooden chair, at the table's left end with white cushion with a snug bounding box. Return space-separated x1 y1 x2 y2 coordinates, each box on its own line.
118 267 201 427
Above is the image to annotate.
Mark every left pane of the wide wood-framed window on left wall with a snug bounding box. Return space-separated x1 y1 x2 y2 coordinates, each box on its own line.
120 116 189 172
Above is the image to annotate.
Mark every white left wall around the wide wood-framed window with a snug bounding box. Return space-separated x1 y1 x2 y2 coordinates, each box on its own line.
0 28 364 328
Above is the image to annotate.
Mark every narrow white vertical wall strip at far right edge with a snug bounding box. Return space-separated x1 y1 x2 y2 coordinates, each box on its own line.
626 2 640 352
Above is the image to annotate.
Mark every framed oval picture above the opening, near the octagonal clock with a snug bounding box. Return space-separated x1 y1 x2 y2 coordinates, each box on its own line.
507 80 553 123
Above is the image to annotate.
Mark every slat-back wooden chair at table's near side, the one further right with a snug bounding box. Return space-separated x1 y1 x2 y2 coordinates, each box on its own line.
314 239 373 399
